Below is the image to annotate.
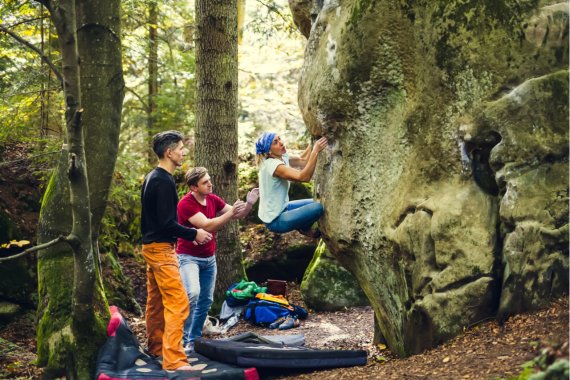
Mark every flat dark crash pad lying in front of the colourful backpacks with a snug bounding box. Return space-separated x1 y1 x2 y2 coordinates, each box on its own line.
194 338 367 369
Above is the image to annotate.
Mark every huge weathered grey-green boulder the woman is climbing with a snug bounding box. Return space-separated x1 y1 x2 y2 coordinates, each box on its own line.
297 0 568 356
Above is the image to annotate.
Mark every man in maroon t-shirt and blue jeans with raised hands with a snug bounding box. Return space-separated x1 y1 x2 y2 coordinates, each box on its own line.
176 167 259 350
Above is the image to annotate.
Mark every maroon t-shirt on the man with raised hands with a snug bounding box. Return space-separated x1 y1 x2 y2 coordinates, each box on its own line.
176 192 226 257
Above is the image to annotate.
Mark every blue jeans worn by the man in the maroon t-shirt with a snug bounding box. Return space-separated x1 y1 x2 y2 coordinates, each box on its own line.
178 254 218 345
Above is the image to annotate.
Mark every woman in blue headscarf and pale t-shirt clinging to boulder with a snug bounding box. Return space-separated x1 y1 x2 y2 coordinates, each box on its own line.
255 132 327 237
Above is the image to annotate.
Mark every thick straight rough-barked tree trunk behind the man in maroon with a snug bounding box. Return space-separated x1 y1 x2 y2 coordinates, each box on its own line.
195 0 244 305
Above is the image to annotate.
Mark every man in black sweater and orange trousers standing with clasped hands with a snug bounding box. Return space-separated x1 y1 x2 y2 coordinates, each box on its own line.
141 131 212 371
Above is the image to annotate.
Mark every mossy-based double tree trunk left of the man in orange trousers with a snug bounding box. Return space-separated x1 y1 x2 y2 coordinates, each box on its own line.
37 0 123 379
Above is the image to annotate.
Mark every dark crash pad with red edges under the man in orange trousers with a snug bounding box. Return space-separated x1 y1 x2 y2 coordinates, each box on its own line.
95 306 259 380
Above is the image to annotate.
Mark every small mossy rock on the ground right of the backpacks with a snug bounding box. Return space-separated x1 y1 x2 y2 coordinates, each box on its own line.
301 241 370 311
